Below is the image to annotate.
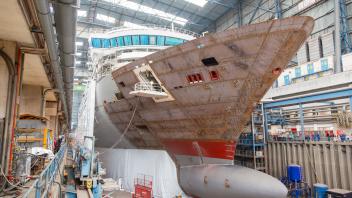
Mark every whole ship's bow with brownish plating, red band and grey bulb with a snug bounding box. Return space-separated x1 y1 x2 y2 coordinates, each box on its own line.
95 17 314 197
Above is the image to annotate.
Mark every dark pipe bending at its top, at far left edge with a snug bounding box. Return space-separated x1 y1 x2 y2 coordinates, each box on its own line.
0 49 18 172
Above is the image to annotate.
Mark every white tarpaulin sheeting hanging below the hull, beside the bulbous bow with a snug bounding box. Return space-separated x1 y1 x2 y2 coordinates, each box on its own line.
96 148 184 198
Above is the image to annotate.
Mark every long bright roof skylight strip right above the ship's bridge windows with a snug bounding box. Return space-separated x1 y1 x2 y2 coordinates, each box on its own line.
103 0 188 26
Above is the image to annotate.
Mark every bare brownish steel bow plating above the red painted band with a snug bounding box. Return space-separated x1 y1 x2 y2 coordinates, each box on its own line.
95 17 313 165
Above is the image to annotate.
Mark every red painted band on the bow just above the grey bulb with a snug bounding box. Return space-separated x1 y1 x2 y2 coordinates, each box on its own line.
162 140 236 160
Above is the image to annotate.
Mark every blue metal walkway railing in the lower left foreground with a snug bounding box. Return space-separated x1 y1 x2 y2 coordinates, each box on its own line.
22 144 66 198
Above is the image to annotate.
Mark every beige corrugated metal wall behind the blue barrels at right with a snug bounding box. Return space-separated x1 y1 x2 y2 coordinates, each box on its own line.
265 142 352 190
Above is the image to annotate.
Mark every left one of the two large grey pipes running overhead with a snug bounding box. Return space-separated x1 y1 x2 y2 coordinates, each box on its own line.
35 0 70 123
